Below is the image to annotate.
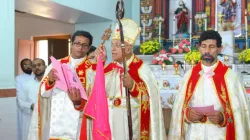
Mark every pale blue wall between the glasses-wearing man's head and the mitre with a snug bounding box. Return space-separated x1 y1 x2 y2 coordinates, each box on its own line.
76 21 114 62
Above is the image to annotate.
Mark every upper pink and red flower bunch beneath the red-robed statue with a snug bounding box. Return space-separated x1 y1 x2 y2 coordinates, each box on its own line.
169 39 191 54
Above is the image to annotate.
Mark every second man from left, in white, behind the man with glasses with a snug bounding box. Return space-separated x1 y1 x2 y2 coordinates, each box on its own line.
17 58 46 140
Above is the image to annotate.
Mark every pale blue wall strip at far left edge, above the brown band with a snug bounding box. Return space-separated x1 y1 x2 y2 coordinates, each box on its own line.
0 0 15 89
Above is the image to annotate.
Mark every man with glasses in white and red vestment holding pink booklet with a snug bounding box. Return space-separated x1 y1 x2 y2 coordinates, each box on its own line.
28 31 93 140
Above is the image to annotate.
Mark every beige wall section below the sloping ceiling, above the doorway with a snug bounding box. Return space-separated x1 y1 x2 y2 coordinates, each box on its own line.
15 13 75 40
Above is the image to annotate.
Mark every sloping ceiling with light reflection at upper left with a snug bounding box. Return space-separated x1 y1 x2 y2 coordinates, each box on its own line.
15 0 110 24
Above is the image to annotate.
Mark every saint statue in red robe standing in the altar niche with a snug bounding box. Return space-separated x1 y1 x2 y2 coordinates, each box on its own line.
174 0 189 34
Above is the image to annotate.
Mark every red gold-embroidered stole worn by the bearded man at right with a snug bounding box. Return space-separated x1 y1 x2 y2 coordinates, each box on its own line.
181 61 235 140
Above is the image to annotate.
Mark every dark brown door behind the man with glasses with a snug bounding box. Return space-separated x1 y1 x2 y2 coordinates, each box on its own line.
48 39 69 64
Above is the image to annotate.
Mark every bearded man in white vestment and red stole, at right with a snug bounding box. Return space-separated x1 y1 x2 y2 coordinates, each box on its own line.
169 30 250 140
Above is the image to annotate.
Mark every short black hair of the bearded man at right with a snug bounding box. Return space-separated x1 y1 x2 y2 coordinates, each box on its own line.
199 30 222 48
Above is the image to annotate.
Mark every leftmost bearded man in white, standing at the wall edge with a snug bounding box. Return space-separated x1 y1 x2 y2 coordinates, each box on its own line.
16 58 34 140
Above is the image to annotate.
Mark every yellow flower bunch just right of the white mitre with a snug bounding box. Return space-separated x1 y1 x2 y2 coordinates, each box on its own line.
140 39 160 54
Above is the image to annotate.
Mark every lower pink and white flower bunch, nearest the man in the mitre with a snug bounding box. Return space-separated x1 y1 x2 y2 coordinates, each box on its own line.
152 50 174 65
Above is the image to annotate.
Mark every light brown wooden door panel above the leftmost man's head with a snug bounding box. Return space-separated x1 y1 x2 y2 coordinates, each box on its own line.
16 39 35 74
